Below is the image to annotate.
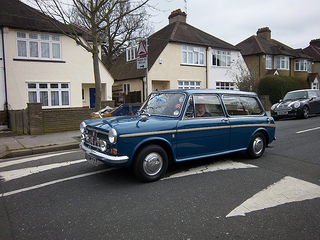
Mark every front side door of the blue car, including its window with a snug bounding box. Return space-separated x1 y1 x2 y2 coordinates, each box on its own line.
176 94 230 161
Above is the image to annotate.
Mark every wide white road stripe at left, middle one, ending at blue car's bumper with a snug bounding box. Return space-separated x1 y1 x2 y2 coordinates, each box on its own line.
0 159 87 182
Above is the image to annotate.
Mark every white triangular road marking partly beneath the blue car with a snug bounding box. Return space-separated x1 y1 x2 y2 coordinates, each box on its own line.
161 160 257 180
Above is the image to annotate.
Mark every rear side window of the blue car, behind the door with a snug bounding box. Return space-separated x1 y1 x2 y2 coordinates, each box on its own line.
223 95 264 116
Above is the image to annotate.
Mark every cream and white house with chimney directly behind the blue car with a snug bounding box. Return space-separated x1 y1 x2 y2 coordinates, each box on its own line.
110 9 245 102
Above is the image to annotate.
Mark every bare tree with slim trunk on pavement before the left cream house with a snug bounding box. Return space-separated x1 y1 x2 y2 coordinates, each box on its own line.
33 0 149 110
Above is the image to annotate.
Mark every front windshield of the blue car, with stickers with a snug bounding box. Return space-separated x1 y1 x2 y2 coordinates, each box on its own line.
139 93 185 117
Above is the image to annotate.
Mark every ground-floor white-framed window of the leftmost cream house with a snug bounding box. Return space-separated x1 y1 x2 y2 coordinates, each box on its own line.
27 83 70 108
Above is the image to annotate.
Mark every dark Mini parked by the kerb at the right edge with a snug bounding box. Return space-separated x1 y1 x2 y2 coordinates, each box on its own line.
271 89 320 120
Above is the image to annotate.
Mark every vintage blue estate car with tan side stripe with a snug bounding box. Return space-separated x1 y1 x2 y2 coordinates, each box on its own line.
80 89 275 182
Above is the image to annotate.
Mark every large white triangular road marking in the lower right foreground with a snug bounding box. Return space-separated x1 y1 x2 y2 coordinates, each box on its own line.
226 177 320 217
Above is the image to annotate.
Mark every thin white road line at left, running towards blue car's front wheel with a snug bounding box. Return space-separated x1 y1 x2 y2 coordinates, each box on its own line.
0 168 116 197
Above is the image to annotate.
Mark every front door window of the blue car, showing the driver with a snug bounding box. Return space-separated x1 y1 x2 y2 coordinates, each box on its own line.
185 94 224 118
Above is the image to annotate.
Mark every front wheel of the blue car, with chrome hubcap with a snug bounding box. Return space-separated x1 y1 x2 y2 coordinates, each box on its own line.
133 145 168 182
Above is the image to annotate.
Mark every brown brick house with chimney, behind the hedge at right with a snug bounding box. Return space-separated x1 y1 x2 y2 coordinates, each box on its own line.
236 27 313 87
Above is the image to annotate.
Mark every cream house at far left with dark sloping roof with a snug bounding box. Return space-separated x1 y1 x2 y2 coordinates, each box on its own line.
0 0 113 126
